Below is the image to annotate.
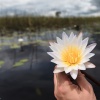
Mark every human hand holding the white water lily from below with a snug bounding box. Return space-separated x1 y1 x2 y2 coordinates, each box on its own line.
54 67 96 100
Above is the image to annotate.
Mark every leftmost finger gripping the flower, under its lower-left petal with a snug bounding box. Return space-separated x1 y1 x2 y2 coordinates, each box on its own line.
54 66 76 92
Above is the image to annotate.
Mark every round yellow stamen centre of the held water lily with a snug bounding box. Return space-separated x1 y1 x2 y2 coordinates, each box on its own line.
61 46 82 66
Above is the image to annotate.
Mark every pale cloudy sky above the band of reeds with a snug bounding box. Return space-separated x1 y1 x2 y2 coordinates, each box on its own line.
0 0 100 16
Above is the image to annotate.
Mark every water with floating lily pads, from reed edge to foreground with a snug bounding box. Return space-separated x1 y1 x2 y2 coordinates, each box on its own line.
0 30 100 100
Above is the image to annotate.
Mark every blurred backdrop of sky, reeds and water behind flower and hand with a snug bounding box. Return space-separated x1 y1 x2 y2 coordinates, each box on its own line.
0 0 100 100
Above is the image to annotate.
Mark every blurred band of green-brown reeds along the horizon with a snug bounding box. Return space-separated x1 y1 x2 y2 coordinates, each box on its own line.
0 16 100 34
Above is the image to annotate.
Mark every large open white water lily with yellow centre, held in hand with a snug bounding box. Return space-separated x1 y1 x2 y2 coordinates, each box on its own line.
47 32 96 79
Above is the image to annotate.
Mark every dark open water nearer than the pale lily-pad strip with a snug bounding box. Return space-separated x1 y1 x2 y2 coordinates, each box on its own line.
0 30 100 100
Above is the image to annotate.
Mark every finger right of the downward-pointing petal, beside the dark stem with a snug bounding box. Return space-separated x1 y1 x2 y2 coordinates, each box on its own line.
76 71 89 89
